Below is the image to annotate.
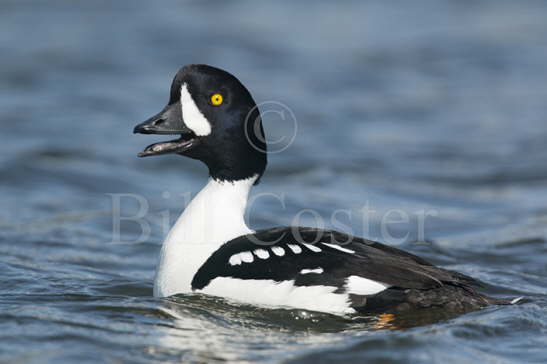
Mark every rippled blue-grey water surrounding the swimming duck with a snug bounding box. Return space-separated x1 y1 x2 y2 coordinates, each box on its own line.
0 0 547 363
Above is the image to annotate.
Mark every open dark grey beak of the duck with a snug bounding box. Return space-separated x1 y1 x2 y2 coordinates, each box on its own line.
133 102 198 157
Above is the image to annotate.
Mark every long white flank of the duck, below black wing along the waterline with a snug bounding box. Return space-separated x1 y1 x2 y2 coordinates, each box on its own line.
201 277 355 314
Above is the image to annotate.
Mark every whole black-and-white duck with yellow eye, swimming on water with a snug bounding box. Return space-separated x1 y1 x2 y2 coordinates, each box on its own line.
134 65 512 314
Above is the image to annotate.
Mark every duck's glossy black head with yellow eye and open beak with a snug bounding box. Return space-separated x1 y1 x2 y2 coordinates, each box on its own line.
134 65 267 181
